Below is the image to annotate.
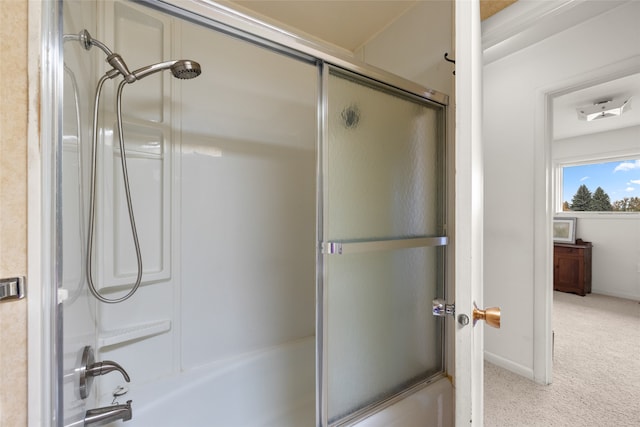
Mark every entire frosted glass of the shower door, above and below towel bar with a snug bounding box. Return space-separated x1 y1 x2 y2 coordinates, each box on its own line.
323 68 445 423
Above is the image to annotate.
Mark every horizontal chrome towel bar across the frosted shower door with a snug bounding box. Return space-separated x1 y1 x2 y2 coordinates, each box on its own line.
322 236 449 255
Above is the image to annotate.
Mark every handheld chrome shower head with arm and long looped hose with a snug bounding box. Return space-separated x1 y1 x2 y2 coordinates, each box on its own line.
64 30 202 304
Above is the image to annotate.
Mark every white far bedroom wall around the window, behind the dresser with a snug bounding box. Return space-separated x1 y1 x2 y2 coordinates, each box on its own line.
552 126 640 300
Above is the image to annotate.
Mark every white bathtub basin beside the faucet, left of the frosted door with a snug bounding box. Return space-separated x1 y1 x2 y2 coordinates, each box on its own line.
127 337 315 427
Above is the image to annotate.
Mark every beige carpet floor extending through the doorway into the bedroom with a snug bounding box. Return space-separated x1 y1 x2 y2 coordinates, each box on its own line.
484 292 640 427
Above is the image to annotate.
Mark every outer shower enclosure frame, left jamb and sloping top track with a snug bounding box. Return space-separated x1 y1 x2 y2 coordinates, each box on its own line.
29 0 476 426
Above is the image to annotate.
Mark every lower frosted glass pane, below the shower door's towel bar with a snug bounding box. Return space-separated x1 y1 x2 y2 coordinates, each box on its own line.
327 248 442 420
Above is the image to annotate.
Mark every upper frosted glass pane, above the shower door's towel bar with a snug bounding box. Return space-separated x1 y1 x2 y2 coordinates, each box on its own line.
325 75 441 240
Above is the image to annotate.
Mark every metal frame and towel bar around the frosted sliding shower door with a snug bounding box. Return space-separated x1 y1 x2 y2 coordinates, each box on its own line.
316 62 453 427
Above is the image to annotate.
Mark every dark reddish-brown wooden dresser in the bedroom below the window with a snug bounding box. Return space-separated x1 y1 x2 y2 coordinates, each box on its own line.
553 239 593 296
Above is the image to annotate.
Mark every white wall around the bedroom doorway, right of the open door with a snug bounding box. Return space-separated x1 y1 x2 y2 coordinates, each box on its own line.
484 2 640 378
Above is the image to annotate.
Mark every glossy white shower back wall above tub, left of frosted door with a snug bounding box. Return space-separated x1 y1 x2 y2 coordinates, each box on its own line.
180 18 318 370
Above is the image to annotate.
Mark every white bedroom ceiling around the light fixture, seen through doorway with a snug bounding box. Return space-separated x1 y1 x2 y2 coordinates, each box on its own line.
553 74 640 139
